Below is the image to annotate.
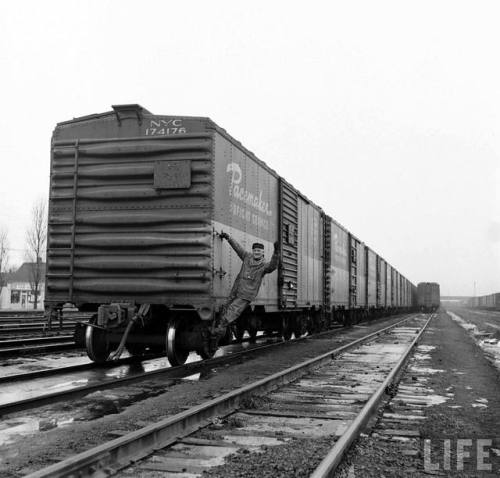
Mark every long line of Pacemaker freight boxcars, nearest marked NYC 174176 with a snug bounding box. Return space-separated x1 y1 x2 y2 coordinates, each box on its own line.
45 105 416 364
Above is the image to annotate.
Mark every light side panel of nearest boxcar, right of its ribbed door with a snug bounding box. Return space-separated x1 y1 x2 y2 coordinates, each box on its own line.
297 197 323 307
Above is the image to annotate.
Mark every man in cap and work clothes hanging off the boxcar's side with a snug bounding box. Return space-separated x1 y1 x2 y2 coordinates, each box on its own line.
214 232 280 341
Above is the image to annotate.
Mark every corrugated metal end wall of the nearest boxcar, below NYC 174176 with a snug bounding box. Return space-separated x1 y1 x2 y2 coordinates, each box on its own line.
47 134 212 303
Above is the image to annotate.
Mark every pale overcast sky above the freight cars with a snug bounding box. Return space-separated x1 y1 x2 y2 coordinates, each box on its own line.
0 0 500 295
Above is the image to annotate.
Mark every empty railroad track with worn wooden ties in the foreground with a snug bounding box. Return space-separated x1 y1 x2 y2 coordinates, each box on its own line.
22 315 432 478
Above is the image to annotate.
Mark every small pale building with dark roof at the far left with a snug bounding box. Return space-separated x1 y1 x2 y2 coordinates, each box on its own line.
0 262 45 310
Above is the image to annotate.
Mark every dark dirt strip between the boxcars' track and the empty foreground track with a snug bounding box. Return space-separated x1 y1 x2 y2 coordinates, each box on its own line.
0 317 410 477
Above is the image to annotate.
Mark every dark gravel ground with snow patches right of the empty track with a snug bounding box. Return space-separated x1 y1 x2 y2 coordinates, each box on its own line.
336 313 500 478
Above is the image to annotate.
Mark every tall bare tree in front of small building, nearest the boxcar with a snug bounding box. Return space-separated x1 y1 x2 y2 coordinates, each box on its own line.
26 199 47 309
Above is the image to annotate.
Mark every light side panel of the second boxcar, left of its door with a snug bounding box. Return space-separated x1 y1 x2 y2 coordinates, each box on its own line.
331 221 349 308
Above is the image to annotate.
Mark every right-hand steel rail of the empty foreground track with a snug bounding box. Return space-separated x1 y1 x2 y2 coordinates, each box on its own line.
310 314 435 478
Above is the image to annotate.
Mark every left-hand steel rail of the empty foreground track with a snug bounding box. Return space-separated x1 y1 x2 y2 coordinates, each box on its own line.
27 314 422 478
